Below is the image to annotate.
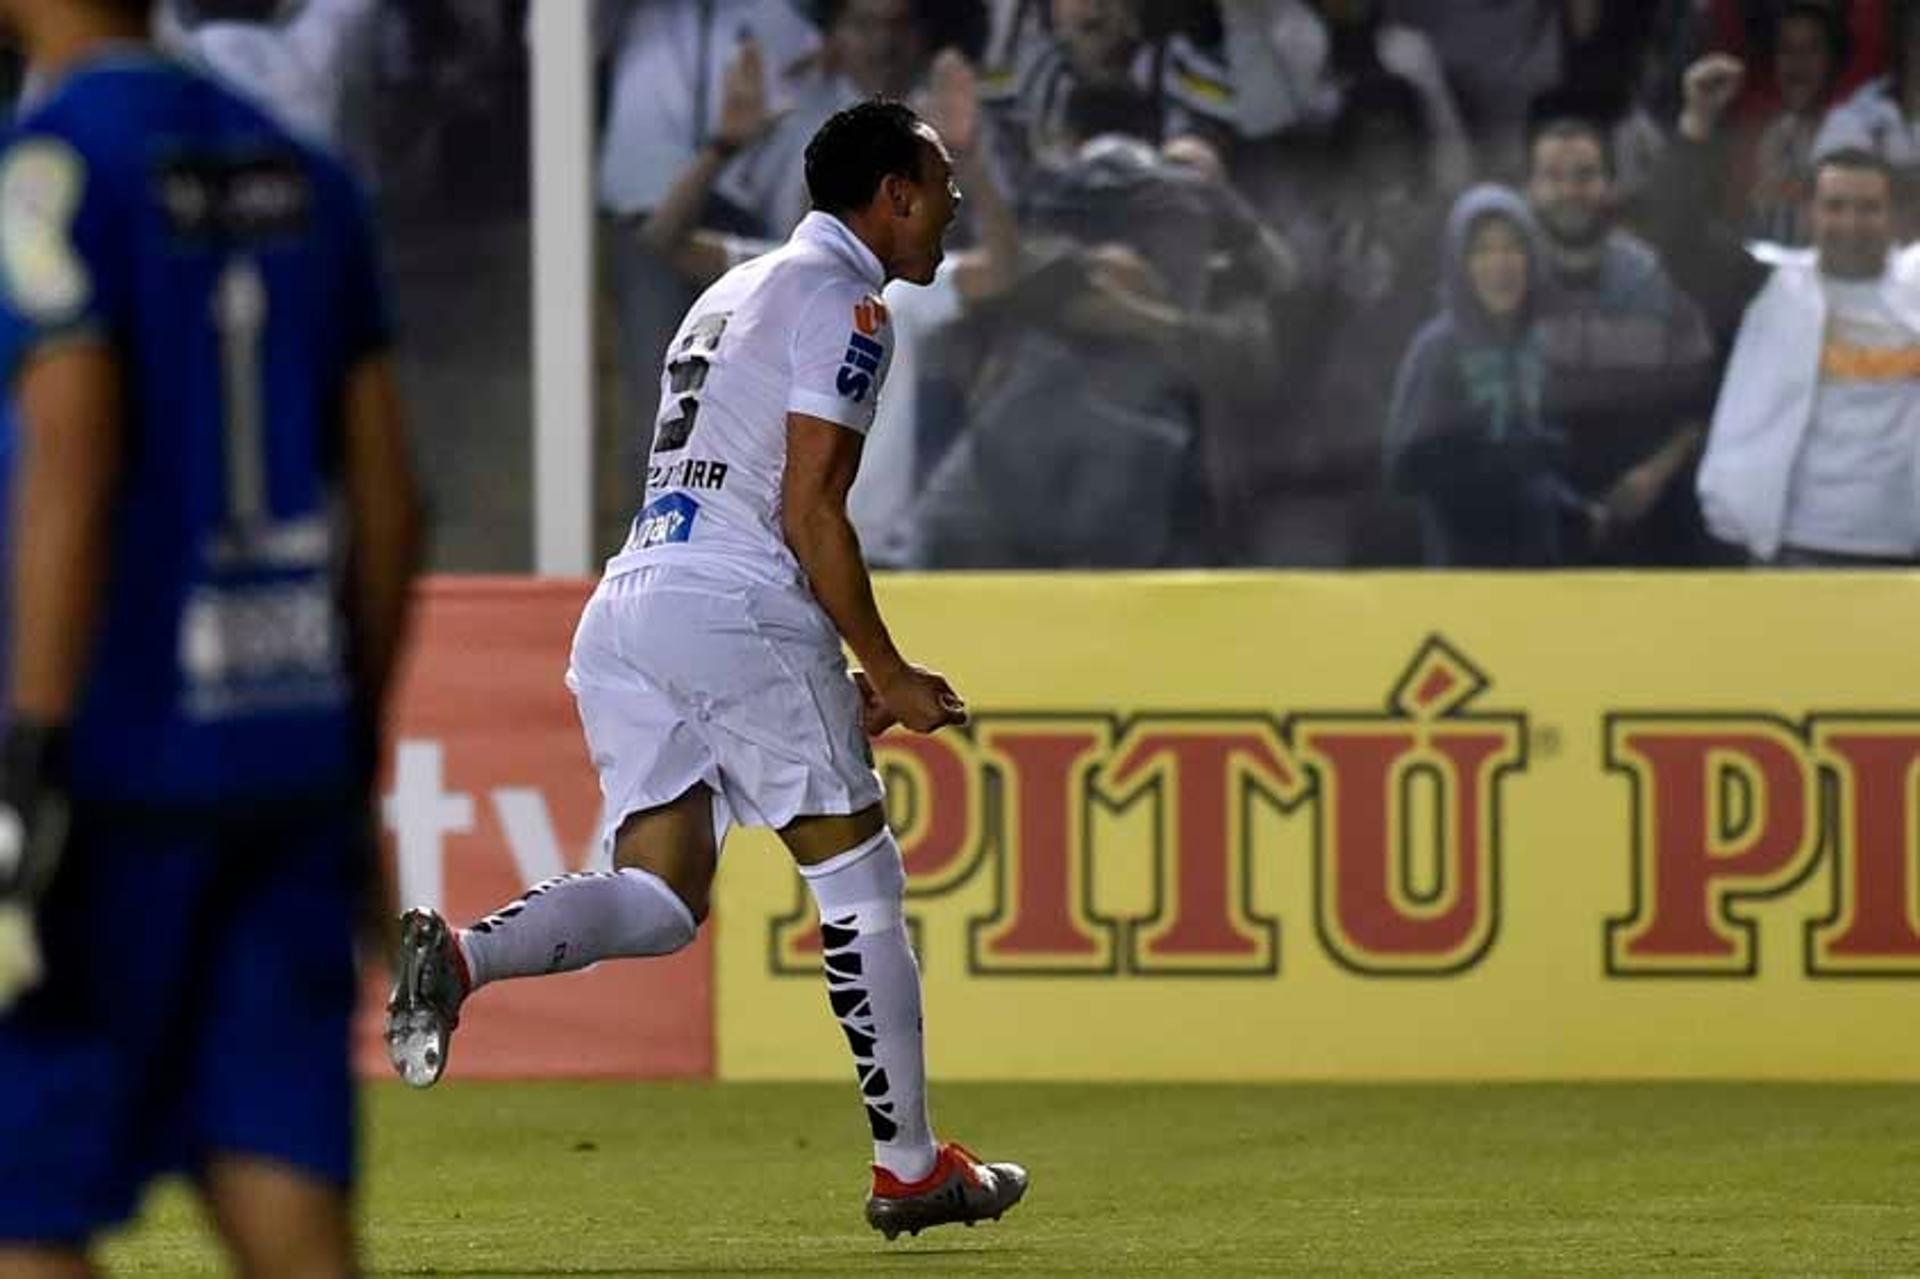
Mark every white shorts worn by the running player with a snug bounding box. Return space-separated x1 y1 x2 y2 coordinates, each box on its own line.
566 568 881 858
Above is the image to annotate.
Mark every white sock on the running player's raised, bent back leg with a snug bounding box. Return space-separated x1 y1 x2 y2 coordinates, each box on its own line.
459 866 699 991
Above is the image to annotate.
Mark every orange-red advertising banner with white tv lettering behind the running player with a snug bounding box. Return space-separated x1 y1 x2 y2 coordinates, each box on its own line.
355 578 714 1079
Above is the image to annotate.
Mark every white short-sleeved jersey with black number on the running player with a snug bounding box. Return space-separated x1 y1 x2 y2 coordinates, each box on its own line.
607 213 893 586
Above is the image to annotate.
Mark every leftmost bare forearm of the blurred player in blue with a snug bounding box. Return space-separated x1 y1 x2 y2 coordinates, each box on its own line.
13 344 123 726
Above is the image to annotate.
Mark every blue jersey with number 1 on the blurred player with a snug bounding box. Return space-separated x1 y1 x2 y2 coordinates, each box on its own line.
0 52 390 807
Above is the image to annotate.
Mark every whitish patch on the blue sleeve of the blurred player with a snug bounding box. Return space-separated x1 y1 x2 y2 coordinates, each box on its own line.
0 138 94 325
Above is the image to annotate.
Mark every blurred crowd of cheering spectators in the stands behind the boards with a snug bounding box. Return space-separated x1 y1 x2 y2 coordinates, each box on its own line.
15 0 1920 568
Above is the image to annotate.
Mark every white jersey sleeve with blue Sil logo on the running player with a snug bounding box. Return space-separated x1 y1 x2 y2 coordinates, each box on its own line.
787 280 893 436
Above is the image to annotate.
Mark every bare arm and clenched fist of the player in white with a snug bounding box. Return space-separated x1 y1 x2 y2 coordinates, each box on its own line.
780 413 966 734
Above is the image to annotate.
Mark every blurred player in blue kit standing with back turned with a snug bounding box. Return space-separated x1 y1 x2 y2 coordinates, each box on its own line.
0 0 420 1275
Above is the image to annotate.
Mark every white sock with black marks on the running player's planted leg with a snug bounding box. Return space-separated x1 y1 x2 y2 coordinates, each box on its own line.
801 830 937 1181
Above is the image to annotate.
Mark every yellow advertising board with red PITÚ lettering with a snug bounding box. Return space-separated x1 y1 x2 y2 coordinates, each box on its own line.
716 572 1920 1079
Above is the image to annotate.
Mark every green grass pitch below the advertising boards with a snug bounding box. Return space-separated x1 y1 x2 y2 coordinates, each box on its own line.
106 1081 1920 1275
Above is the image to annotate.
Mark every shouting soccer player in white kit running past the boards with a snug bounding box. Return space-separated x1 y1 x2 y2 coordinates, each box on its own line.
388 102 1027 1239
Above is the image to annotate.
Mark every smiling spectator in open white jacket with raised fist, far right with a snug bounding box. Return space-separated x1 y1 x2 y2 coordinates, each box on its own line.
1649 56 1920 567
